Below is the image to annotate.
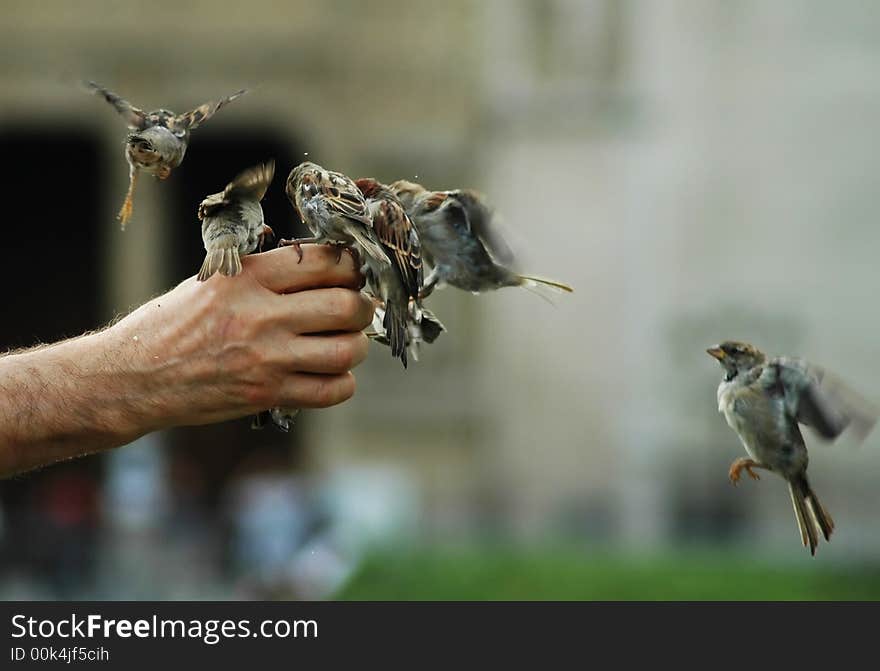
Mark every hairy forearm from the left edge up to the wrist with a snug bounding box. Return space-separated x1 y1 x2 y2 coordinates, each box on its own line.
0 330 146 476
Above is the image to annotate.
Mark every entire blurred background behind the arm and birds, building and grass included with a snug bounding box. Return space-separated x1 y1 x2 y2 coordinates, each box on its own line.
0 0 880 599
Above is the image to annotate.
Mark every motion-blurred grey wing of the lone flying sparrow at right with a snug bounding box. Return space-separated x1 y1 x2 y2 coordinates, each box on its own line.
761 357 878 440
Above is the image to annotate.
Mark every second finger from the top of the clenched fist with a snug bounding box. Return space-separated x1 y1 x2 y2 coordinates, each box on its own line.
278 288 373 333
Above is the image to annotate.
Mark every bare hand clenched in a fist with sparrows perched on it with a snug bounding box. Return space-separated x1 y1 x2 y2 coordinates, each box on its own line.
104 245 373 435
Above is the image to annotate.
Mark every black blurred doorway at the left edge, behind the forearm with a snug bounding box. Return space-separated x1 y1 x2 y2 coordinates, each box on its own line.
0 123 104 595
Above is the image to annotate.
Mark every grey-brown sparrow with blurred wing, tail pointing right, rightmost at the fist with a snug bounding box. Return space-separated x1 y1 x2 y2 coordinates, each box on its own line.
391 180 572 298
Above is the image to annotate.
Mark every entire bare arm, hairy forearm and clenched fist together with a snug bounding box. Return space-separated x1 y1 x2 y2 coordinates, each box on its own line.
0 245 373 476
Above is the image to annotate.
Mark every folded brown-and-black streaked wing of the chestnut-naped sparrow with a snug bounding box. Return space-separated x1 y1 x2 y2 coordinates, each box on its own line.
372 192 422 298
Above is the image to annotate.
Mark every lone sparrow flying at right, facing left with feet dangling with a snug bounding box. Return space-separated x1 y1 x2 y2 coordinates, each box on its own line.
706 341 877 555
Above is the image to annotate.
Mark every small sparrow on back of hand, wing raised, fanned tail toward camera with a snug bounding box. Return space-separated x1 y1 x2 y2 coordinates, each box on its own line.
198 161 275 282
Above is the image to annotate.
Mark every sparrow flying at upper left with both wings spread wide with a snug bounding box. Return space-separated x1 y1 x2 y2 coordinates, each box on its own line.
84 82 247 230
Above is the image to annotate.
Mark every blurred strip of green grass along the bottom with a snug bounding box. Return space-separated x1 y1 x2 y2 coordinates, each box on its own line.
336 549 880 601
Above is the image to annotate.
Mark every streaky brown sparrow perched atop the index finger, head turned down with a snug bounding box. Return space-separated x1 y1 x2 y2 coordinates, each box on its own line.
278 161 391 265
